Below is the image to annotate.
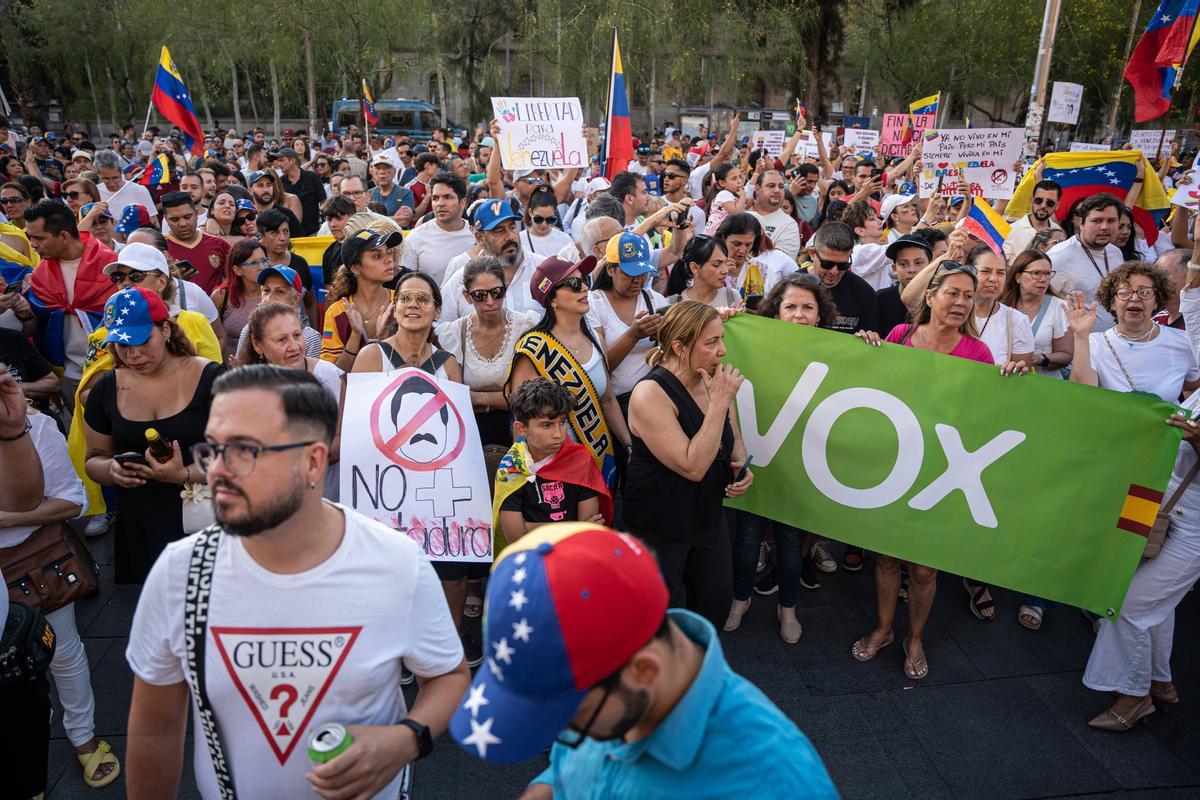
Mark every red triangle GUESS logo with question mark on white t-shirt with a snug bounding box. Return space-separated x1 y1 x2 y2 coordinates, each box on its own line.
210 626 362 765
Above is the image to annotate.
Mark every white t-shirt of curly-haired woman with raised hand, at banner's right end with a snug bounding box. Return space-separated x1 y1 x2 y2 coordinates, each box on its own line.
1087 325 1200 403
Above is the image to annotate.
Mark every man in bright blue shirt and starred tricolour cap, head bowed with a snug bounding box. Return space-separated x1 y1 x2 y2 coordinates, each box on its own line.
450 522 838 800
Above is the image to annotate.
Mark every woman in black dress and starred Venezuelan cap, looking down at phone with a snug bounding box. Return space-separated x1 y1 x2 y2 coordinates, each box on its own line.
83 287 224 584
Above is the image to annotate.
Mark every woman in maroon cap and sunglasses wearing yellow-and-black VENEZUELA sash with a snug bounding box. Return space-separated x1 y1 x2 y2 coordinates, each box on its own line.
504 255 630 489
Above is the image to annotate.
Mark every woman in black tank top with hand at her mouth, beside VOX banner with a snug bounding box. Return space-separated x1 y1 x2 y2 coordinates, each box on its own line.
625 300 754 625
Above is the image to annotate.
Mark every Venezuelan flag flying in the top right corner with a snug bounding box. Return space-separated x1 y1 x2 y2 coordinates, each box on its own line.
1124 0 1200 122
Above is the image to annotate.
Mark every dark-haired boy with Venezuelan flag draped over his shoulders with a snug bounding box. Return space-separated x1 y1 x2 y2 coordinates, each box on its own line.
493 378 612 543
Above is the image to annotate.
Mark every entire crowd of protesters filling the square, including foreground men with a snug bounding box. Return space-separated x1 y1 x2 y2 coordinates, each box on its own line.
0 107 1200 798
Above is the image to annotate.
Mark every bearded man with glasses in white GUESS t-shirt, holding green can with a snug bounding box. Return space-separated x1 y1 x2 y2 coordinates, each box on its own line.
126 365 470 800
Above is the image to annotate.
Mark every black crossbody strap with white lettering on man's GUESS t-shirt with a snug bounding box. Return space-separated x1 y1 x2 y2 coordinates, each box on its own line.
184 525 238 800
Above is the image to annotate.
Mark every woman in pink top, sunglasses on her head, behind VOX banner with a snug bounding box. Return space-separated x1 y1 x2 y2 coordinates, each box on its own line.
851 260 1024 680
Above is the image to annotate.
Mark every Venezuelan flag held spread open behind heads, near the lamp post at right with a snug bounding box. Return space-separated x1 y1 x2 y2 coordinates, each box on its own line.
1006 150 1170 245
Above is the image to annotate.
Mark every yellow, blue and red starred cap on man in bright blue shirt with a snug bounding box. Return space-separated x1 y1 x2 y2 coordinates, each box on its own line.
450 522 667 764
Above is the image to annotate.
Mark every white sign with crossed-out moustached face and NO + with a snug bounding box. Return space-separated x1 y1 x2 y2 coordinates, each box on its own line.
341 367 492 561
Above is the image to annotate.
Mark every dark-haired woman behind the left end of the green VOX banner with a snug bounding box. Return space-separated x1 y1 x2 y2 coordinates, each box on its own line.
725 272 838 644
